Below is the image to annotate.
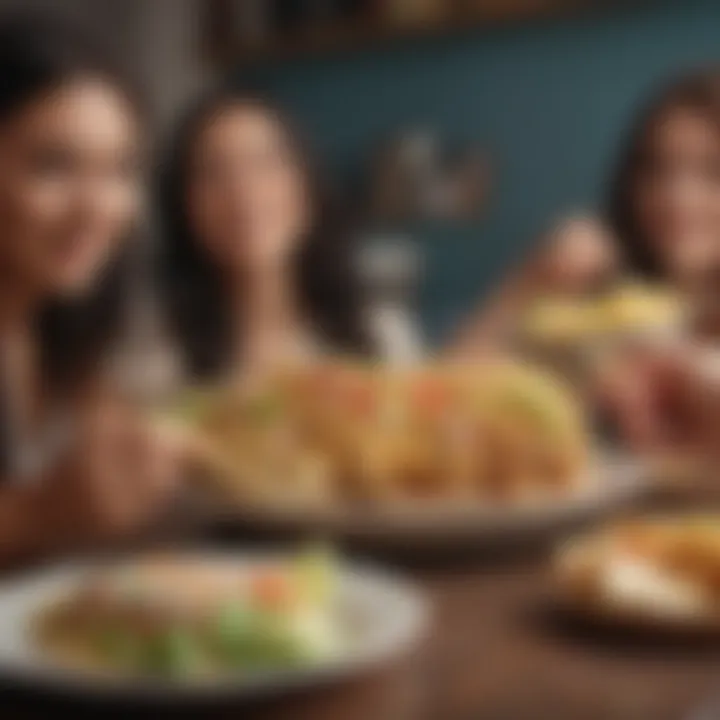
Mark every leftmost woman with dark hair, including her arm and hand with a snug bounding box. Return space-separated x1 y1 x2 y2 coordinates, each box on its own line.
0 16 180 563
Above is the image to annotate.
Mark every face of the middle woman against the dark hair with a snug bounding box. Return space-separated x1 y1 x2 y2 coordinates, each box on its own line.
187 105 310 272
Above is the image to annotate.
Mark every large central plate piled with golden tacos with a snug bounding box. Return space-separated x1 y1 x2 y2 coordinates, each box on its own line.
170 361 645 545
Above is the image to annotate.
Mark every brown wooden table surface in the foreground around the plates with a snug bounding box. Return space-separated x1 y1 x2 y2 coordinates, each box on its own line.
5 560 720 720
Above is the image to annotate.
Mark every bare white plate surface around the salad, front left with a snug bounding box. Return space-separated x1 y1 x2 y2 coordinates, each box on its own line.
0 554 429 702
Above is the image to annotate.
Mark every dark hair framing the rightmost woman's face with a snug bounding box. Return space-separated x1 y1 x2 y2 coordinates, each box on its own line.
608 68 720 277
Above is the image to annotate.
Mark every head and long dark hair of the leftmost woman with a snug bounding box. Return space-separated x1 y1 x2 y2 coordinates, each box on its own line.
0 19 143 416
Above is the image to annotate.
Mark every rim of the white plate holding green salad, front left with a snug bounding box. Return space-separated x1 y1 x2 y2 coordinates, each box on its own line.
0 548 432 704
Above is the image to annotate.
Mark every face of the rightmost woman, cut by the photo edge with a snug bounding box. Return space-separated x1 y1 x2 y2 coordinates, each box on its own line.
635 108 720 281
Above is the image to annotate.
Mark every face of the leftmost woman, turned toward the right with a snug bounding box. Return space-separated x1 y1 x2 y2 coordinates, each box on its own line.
0 78 139 295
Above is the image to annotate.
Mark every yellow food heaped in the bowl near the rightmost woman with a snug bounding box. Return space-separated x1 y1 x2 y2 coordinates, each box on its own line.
522 283 684 345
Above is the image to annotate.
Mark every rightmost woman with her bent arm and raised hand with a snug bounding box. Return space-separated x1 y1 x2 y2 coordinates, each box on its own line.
459 70 720 351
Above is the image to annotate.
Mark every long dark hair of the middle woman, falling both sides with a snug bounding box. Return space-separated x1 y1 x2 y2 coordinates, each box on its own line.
159 88 365 379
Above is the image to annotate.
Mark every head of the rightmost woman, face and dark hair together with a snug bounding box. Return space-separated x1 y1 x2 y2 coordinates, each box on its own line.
608 70 720 289
